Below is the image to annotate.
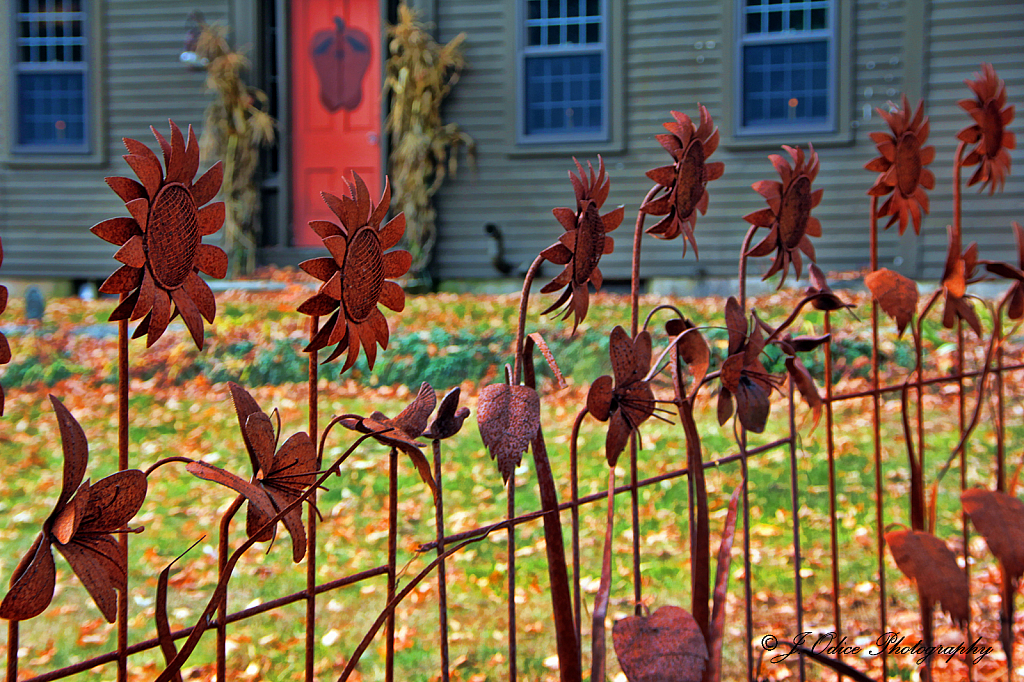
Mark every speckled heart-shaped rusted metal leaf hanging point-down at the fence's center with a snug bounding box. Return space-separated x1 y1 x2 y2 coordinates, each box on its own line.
476 384 541 482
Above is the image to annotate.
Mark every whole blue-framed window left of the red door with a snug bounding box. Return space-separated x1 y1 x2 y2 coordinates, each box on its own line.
11 0 90 153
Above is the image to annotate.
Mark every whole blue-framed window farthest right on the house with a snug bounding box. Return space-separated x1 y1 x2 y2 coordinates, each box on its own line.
737 0 837 134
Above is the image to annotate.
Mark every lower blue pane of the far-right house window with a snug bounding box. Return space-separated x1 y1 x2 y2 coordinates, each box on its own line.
742 40 829 126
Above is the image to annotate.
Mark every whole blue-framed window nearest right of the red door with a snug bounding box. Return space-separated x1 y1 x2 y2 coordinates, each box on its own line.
518 0 608 143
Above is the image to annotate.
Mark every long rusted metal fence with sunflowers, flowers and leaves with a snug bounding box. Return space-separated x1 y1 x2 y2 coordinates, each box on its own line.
0 65 1024 681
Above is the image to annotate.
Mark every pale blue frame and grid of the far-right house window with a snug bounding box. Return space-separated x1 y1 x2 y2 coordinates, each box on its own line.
732 0 840 137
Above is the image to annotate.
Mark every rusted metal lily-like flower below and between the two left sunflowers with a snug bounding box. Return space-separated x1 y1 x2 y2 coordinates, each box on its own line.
227 382 317 563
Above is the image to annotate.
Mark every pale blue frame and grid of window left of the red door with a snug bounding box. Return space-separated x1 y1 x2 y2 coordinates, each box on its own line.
8 0 93 155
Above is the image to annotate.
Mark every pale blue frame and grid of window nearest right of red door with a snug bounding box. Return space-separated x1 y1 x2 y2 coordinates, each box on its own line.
515 0 611 145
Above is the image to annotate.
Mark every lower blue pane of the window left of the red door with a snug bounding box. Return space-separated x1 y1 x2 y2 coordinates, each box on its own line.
17 74 85 146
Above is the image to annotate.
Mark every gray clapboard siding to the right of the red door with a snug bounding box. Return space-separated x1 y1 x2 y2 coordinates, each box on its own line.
435 0 1024 280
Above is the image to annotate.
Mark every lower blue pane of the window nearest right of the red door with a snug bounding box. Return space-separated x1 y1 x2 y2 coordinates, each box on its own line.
524 54 603 135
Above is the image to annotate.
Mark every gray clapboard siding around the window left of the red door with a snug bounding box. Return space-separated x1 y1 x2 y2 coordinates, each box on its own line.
0 0 228 280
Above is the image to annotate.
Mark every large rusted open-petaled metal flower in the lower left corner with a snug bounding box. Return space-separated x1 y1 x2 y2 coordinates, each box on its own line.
0 395 146 623
